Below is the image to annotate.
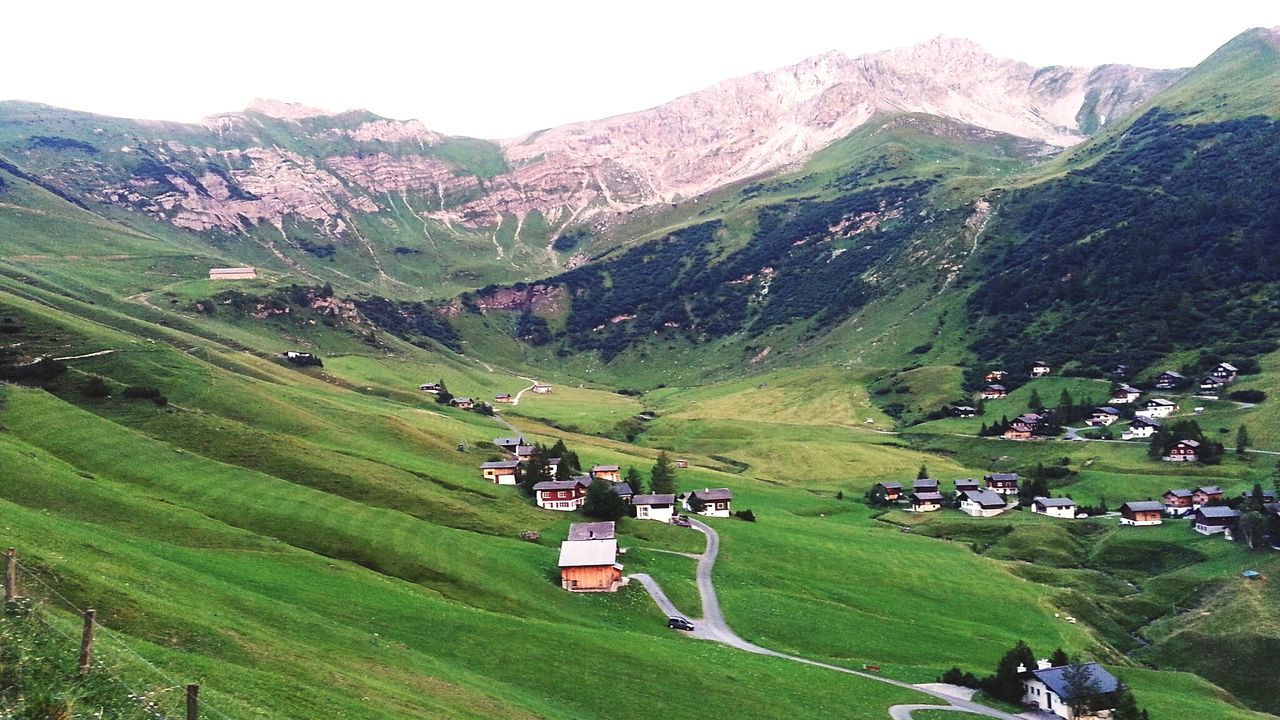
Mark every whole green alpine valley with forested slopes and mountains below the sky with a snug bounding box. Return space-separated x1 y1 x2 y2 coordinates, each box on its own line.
0 28 1280 720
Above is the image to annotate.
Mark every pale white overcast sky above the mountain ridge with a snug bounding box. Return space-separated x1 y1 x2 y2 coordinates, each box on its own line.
0 0 1280 137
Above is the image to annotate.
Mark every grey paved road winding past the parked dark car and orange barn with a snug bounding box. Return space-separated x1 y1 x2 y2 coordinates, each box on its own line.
631 520 1025 720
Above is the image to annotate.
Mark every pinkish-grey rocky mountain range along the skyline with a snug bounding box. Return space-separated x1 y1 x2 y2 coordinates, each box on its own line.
0 38 1180 254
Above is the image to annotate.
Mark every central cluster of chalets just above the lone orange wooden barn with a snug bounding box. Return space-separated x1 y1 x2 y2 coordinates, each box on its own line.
480 437 733 523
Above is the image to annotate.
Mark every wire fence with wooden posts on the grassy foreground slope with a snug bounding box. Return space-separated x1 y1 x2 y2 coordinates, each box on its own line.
0 560 240 720
